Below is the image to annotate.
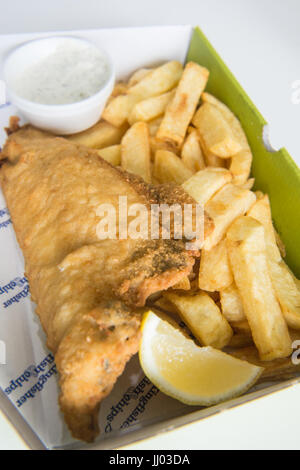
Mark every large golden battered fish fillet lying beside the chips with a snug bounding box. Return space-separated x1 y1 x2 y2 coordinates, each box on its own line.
0 126 212 441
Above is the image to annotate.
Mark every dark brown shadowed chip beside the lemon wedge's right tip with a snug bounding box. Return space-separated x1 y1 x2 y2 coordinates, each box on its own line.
230 346 300 382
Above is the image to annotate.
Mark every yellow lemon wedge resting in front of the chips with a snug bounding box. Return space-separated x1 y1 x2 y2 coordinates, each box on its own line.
139 310 263 406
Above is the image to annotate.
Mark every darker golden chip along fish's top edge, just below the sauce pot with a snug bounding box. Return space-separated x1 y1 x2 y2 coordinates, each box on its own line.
65 121 128 149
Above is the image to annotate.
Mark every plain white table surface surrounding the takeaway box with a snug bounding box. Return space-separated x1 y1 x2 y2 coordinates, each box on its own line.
0 0 300 450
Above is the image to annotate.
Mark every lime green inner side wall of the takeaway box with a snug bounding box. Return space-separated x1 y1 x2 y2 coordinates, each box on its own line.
187 28 300 278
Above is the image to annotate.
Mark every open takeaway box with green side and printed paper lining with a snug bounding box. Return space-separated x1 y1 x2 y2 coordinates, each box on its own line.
0 26 300 449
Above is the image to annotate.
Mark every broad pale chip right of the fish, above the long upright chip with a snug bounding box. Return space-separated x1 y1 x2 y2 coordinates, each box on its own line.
203 183 256 250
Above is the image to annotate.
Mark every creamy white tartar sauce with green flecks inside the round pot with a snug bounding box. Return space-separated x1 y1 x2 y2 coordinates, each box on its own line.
13 41 109 105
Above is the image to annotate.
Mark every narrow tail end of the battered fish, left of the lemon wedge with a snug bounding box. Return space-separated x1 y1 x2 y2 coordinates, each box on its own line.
56 301 140 442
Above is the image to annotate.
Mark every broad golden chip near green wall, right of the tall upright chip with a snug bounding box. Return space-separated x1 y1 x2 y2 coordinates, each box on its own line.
192 103 242 158
